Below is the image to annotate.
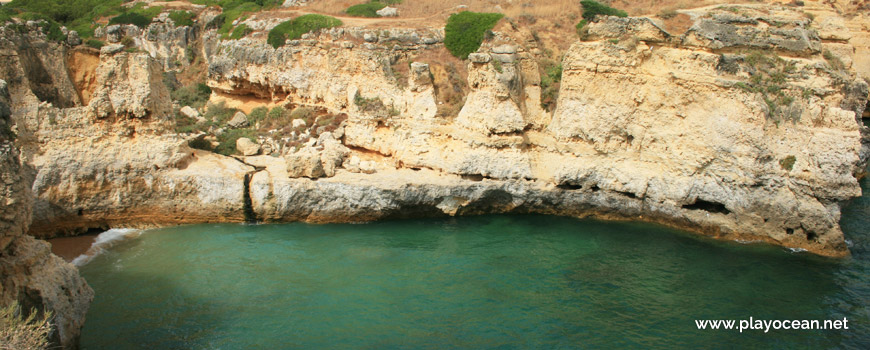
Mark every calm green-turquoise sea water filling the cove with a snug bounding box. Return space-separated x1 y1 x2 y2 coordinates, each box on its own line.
81 181 870 349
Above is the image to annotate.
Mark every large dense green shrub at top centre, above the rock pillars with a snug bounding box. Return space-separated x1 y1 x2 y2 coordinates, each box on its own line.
444 11 503 59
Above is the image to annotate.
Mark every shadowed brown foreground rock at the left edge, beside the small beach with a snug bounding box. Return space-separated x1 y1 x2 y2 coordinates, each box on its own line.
0 80 94 348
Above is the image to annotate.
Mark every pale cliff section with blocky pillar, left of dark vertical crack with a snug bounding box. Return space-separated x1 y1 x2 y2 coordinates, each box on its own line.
13 43 253 237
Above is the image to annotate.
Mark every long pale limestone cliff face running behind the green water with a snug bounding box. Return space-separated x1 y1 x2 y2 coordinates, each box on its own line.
12 2 870 256
